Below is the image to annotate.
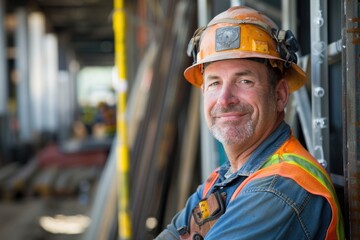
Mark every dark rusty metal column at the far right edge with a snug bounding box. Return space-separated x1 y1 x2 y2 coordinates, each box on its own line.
342 0 360 239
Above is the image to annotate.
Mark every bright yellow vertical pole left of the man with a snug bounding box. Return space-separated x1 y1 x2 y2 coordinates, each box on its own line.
113 0 131 240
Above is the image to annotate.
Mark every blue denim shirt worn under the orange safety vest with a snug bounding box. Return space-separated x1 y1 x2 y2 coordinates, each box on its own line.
156 122 331 240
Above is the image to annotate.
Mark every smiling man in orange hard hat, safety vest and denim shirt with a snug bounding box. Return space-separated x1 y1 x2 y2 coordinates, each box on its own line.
156 7 344 239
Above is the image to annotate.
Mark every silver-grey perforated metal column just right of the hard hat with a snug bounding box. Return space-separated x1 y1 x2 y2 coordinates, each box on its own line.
310 0 329 168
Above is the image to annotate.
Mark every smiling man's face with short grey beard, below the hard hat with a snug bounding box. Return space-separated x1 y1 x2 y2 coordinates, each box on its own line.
202 59 287 146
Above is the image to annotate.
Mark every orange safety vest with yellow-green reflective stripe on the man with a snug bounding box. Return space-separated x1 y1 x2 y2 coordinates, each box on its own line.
203 136 345 240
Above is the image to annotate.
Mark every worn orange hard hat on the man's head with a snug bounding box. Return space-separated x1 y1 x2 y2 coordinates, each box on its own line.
184 6 306 92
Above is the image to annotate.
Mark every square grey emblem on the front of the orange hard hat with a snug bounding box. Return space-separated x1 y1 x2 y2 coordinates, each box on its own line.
215 26 240 52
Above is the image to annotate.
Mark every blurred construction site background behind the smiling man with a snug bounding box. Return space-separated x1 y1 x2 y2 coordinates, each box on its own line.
0 0 360 240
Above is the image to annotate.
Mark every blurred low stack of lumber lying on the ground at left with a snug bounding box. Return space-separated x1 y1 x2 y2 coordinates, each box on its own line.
0 142 107 200
